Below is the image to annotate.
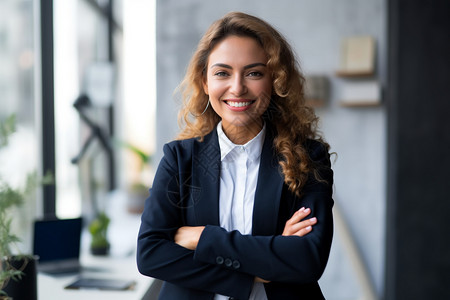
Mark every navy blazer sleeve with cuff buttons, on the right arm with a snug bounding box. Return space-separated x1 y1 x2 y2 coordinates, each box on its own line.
194 143 333 283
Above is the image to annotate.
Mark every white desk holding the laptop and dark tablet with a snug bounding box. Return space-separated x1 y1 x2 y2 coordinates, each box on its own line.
37 255 153 300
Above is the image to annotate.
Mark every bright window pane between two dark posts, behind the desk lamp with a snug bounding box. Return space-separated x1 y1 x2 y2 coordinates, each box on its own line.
54 0 114 218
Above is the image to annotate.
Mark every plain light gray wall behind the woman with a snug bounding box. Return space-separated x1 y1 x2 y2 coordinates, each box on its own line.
155 0 387 299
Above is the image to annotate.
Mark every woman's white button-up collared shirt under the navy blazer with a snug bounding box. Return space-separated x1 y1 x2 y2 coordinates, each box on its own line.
214 122 267 300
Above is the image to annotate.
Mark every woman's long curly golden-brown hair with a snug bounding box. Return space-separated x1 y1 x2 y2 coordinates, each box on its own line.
178 12 329 196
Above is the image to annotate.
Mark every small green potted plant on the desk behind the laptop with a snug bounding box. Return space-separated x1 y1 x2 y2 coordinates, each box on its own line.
89 212 110 255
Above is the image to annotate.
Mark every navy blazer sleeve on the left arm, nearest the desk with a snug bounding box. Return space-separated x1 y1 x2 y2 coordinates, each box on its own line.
137 144 254 299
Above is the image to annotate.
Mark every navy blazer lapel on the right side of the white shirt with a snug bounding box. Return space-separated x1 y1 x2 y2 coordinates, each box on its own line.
252 127 284 235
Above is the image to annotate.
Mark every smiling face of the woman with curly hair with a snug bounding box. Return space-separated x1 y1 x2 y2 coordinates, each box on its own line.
203 36 272 139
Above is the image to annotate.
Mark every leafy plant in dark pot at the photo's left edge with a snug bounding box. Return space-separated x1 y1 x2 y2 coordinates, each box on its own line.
0 115 52 300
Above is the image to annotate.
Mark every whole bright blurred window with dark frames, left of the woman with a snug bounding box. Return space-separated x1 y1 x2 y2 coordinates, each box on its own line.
0 0 156 227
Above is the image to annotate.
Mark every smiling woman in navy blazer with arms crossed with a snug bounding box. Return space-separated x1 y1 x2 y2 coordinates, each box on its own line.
137 12 333 300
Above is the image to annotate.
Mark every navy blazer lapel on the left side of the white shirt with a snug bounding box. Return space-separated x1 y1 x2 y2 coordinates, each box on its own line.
192 129 220 225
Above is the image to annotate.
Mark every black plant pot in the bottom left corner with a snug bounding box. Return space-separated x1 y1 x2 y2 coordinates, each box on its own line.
3 256 38 300
